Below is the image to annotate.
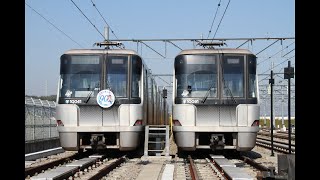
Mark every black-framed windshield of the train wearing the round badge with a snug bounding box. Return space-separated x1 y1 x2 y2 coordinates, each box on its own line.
59 53 142 104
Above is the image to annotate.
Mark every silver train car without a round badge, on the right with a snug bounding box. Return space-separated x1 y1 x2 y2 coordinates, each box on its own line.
172 48 260 151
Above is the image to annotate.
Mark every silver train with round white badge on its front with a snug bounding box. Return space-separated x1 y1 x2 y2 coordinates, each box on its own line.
55 49 164 152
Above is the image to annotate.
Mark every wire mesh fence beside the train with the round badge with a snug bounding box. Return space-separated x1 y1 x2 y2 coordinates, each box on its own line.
25 97 59 142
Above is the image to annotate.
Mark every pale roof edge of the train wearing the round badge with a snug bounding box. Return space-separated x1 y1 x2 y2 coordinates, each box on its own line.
64 49 140 56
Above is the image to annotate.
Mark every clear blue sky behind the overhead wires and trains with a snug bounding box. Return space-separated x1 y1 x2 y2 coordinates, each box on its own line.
25 0 295 96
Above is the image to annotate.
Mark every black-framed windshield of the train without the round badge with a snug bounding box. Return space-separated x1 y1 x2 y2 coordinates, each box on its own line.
175 54 257 104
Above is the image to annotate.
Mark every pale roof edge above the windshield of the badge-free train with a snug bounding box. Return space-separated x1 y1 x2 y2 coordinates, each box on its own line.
178 48 253 55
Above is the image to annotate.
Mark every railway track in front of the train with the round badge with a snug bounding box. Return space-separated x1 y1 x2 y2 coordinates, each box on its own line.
25 150 126 180
